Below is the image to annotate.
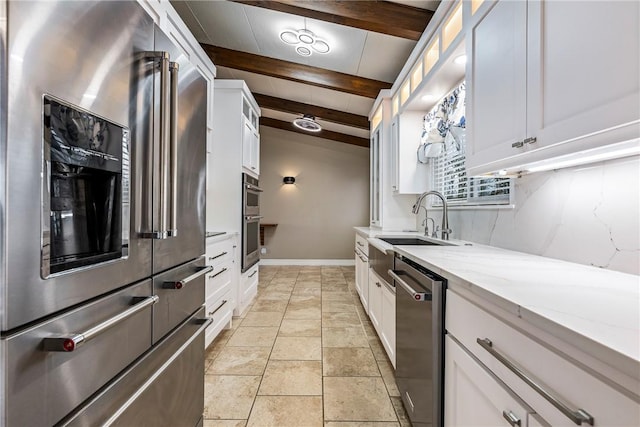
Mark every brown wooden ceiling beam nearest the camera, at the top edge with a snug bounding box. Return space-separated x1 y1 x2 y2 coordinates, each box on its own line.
233 0 433 40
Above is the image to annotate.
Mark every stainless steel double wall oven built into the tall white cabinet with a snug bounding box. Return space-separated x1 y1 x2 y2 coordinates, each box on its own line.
242 173 262 273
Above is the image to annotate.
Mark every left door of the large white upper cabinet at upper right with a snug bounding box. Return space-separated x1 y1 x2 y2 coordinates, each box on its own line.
466 0 527 172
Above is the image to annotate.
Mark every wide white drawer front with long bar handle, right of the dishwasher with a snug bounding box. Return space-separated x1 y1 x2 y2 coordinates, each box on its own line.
445 290 640 426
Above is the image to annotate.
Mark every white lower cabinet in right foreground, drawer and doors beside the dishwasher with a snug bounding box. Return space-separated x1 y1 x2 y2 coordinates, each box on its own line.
445 289 640 426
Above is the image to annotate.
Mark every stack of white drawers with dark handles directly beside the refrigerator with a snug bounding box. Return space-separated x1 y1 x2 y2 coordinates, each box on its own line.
204 234 237 348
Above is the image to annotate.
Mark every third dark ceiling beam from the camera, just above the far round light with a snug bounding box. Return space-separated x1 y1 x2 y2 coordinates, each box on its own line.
253 93 369 130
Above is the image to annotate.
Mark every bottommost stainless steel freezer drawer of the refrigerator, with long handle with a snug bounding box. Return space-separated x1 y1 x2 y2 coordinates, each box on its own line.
60 309 210 427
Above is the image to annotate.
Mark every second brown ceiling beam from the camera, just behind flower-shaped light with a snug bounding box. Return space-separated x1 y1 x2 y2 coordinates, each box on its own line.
201 43 391 98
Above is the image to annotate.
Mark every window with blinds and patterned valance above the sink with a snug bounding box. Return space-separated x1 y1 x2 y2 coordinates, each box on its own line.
424 82 512 205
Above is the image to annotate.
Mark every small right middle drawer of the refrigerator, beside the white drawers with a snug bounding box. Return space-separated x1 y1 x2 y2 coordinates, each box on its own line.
153 257 211 344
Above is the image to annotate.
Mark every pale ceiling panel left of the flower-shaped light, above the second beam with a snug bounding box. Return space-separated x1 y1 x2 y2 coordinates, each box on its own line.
189 1 260 54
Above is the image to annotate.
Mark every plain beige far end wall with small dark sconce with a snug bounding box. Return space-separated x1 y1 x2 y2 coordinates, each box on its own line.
260 126 369 260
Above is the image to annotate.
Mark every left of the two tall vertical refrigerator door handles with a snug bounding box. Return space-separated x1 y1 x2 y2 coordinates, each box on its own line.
140 51 170 240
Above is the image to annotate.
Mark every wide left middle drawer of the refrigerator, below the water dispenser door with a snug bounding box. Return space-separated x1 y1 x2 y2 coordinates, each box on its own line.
0 280 156 426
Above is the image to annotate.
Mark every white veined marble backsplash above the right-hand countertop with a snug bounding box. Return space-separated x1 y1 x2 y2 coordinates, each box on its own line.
418 157 640 274
